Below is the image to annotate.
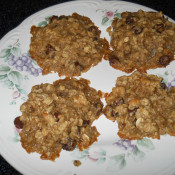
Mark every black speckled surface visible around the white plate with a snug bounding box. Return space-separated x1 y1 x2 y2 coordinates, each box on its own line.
0 0 175 175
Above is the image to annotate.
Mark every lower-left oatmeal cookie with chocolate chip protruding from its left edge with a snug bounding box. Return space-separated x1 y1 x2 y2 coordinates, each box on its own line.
14 78 103 160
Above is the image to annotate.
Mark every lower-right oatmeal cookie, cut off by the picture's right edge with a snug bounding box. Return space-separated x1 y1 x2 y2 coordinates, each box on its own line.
104 71 175 140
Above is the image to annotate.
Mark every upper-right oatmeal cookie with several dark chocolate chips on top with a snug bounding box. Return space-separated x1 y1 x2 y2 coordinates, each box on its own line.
107 10 175 73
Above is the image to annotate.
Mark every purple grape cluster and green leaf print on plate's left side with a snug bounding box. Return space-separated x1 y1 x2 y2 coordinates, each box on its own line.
0 40 42 105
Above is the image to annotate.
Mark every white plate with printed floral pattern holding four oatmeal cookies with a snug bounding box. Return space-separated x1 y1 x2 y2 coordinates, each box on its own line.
0 1 175 175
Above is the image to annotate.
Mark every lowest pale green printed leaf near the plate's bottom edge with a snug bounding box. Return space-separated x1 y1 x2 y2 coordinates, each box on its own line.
107 154 126 172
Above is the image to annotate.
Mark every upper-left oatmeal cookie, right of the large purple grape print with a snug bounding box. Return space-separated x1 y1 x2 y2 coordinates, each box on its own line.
29 13 109 77
